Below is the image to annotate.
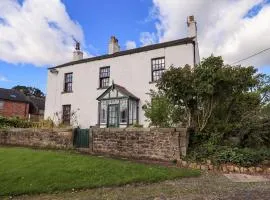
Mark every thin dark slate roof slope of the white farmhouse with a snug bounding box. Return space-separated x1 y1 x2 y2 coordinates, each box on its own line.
48 37 194 70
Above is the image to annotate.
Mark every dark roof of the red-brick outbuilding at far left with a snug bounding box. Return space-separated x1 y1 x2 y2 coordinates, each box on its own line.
0 88 29 103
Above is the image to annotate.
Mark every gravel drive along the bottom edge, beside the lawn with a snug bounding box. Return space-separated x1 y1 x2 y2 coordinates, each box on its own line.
8 172 270 200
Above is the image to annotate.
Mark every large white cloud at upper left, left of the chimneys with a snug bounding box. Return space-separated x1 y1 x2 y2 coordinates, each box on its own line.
0 0 84 66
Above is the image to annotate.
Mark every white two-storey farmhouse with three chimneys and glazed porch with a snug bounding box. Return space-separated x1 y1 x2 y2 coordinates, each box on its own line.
45 16 199 128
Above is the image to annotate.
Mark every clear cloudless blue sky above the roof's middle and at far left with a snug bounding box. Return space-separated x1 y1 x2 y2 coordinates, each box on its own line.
0 0 154 91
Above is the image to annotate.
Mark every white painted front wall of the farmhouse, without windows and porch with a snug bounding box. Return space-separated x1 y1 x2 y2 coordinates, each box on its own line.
45 44 197 128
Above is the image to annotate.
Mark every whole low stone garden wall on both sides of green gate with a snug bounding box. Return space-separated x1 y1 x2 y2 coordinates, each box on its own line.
0 128 188 161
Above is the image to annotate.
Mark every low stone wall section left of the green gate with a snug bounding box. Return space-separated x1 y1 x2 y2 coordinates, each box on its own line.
0 128 73 149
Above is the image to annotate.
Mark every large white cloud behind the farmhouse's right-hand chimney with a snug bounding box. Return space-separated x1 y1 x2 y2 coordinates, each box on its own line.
148 0 270 67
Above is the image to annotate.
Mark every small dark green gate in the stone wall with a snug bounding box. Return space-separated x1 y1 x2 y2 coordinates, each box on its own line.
73 128 89 148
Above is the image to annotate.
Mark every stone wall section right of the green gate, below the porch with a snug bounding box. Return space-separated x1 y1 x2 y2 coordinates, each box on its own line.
90 128 188 161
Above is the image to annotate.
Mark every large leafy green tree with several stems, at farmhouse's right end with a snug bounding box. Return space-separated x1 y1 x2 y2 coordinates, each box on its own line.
157 55 260 131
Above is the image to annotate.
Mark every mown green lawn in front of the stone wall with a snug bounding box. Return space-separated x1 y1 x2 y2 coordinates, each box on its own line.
0 147 200 196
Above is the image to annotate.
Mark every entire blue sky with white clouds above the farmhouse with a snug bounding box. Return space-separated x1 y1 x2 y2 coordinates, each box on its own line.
0 0 270 92
